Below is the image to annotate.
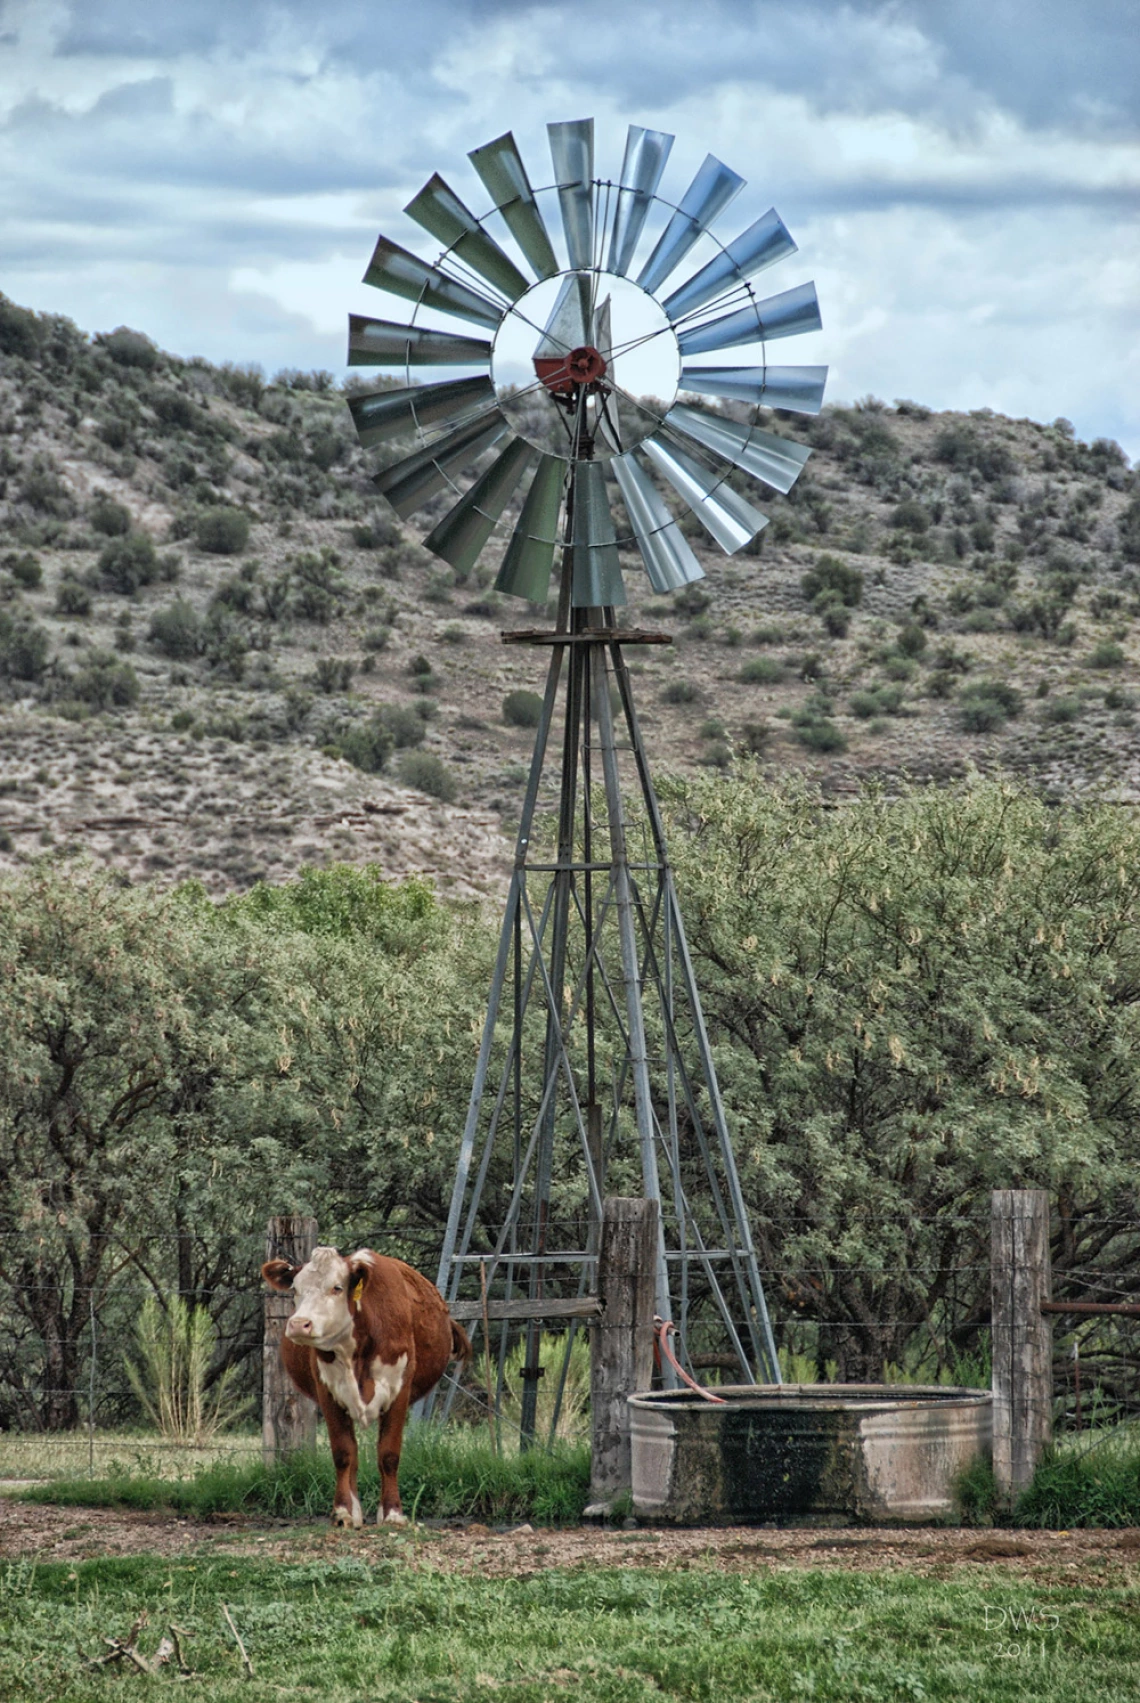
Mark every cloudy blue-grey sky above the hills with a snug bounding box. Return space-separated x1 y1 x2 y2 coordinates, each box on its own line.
0 0 1140 456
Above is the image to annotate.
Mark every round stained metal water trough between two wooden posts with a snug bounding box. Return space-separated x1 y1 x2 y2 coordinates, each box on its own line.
629 1385 992 1526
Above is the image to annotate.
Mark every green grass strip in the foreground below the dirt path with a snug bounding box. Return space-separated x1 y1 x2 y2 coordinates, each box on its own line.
0 1536 1140 1703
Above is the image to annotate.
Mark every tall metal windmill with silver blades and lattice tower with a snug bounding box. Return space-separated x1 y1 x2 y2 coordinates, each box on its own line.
348 119 826 1437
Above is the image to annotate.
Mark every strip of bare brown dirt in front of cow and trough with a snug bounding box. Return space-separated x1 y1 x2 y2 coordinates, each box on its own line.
0 1495 1140 1584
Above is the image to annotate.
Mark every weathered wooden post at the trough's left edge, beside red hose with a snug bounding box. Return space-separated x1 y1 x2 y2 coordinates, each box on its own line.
586 1196 658 1517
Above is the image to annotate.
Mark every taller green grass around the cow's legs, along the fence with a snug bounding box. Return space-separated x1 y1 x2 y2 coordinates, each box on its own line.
24 1425 590 1524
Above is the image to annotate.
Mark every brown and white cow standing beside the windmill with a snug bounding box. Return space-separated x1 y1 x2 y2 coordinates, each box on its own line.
261 1248 470 1526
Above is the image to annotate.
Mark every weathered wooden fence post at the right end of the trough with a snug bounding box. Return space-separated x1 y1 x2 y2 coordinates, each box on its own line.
990 1189 1053 1502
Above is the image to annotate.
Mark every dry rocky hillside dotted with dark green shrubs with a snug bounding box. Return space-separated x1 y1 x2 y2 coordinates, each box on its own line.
0 298 1140 896
